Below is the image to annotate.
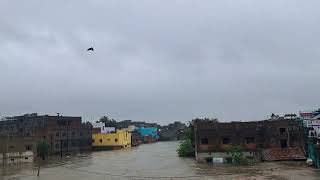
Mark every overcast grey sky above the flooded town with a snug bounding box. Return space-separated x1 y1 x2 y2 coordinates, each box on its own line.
0 0 320 124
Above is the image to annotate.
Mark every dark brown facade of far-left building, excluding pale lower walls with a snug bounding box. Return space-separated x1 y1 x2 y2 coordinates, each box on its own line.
0 113 92 154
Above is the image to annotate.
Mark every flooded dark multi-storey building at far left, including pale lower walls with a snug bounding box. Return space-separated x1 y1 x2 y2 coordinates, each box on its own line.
0 113 92 162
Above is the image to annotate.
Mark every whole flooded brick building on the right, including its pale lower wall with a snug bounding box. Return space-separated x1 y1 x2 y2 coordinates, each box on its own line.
193 117 305 162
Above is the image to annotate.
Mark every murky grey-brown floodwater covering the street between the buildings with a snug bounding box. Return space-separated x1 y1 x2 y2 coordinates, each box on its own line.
0 142 320 180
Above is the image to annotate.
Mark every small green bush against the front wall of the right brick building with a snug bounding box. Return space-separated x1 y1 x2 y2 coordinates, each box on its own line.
225 146 255 166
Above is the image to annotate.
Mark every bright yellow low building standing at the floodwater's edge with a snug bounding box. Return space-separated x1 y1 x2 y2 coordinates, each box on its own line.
92 130 131 150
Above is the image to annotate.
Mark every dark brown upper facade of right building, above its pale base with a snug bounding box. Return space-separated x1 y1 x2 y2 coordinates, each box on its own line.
193 118 305 162
